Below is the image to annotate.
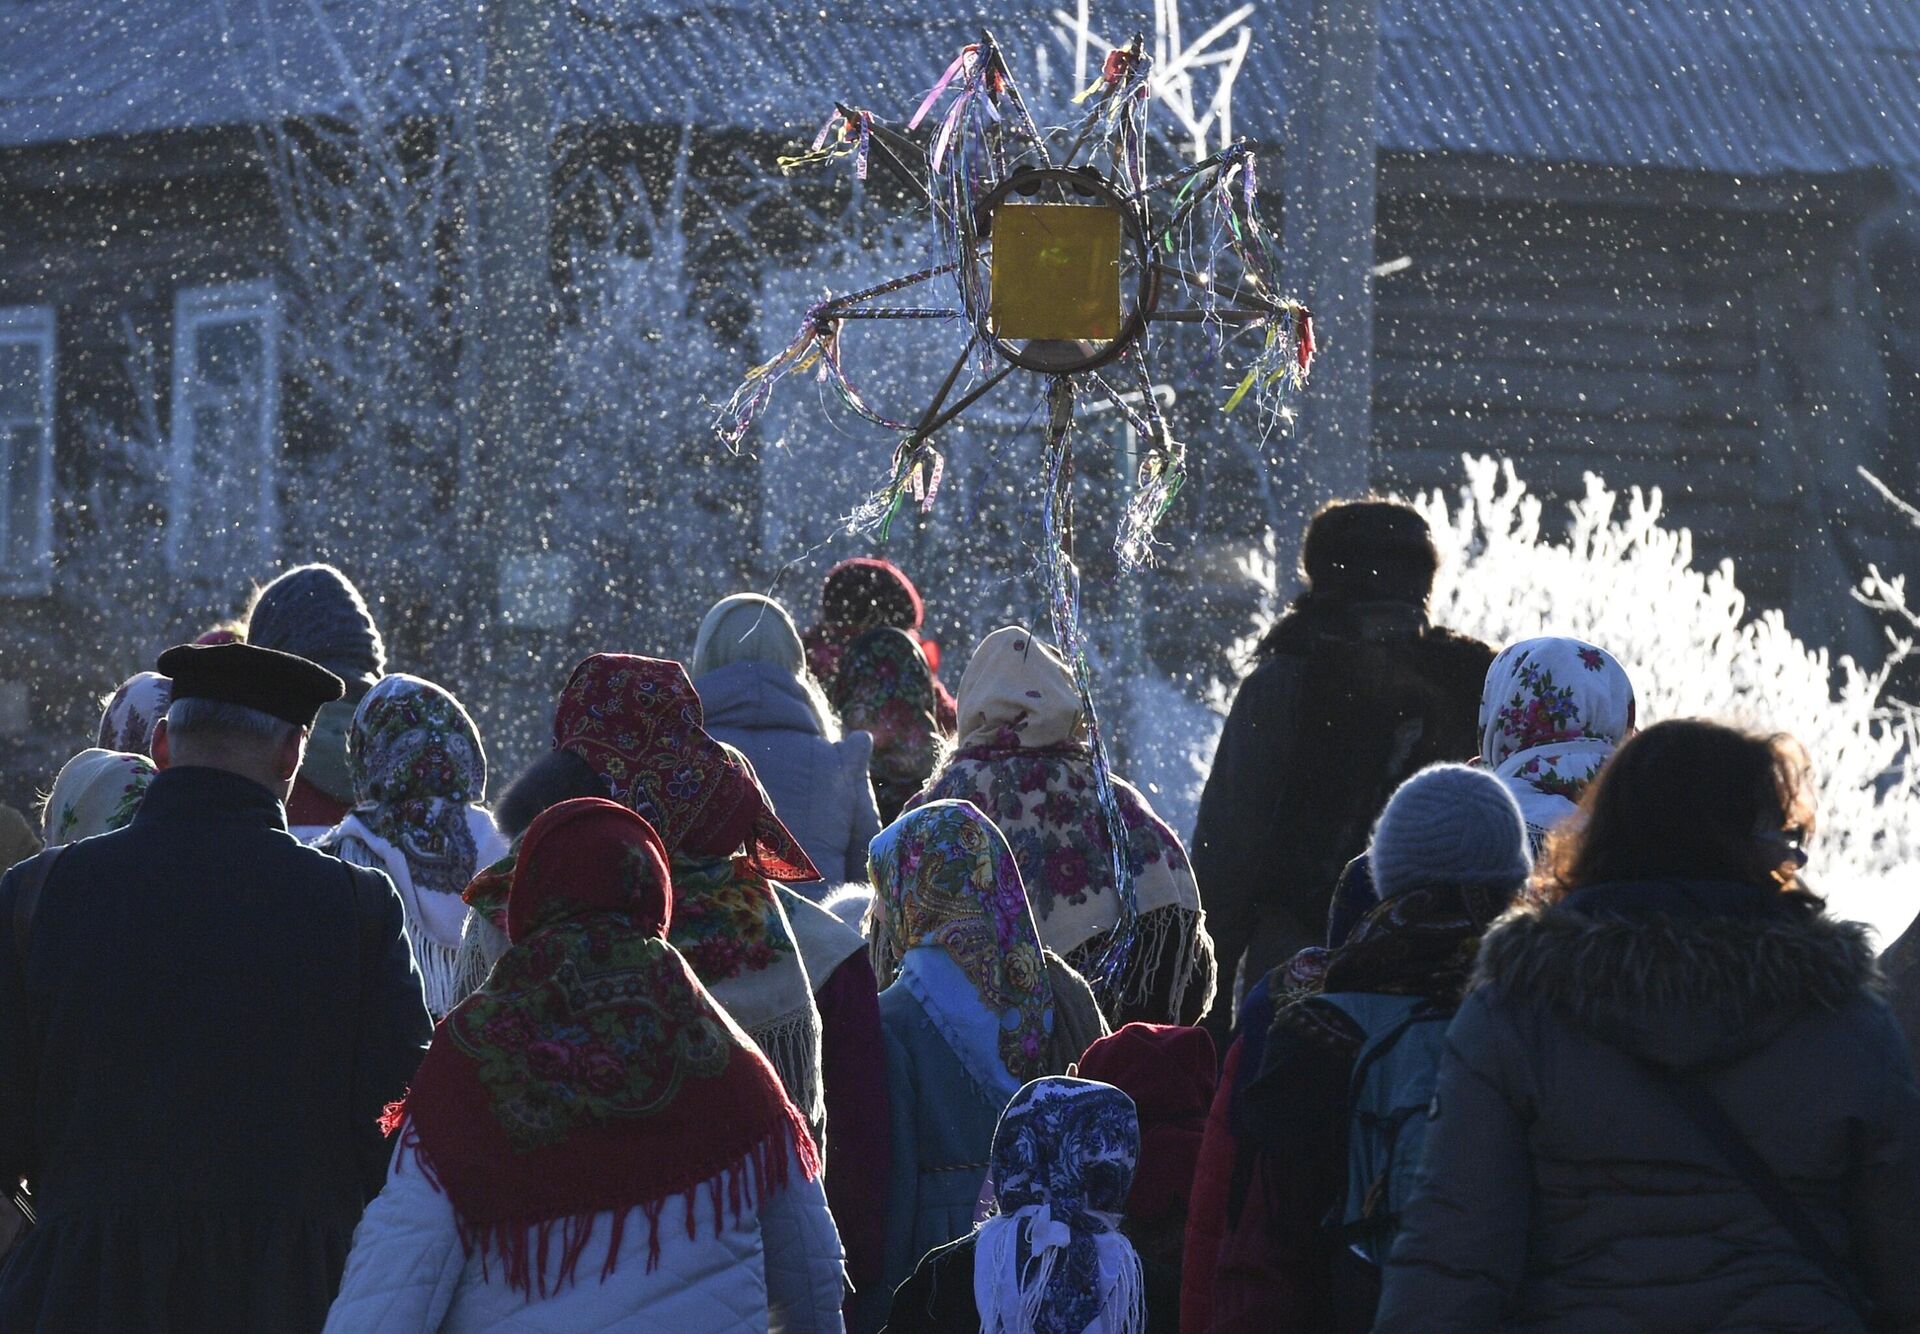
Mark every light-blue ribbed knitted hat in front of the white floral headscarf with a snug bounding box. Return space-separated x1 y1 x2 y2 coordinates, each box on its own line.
1369 764 1534 900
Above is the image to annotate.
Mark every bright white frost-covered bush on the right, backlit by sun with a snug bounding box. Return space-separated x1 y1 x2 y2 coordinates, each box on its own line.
1181 459 1920 941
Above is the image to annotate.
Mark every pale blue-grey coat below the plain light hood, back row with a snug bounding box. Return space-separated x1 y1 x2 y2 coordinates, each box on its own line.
693 662 879 893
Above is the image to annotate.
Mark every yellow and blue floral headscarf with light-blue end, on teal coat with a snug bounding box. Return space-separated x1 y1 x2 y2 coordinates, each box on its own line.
870 800 1054 1092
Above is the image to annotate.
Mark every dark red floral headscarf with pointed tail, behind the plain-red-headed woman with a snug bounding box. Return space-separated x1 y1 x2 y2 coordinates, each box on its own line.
553 653 820 881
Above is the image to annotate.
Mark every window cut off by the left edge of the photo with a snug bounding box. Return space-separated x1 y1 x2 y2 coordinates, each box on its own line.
0 305 54 595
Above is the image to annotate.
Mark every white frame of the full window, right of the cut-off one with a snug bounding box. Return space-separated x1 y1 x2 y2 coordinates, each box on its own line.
165 278 280 570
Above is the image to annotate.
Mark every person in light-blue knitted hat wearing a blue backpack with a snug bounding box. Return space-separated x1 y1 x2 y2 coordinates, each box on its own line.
1212 764 1532 1334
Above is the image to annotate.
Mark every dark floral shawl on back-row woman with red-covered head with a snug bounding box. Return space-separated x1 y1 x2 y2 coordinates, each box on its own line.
833 628 941 820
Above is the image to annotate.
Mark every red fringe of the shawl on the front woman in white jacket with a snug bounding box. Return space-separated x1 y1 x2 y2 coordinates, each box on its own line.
405 1108 820 1299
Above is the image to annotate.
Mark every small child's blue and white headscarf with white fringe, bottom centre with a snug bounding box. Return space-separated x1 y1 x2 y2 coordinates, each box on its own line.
973 1077 1146 1334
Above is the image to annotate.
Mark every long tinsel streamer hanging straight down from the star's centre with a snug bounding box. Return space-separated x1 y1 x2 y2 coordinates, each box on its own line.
1041 376 1140 1006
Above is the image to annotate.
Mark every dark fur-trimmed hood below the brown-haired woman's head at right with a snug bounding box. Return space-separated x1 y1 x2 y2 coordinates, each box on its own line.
1475 881 1882 1067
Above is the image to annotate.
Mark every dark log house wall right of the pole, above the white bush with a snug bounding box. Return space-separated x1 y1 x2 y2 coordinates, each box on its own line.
1375 159 1897 643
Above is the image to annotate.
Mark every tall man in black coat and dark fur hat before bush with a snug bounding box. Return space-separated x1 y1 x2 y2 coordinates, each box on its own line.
1192 501 1494 1046
